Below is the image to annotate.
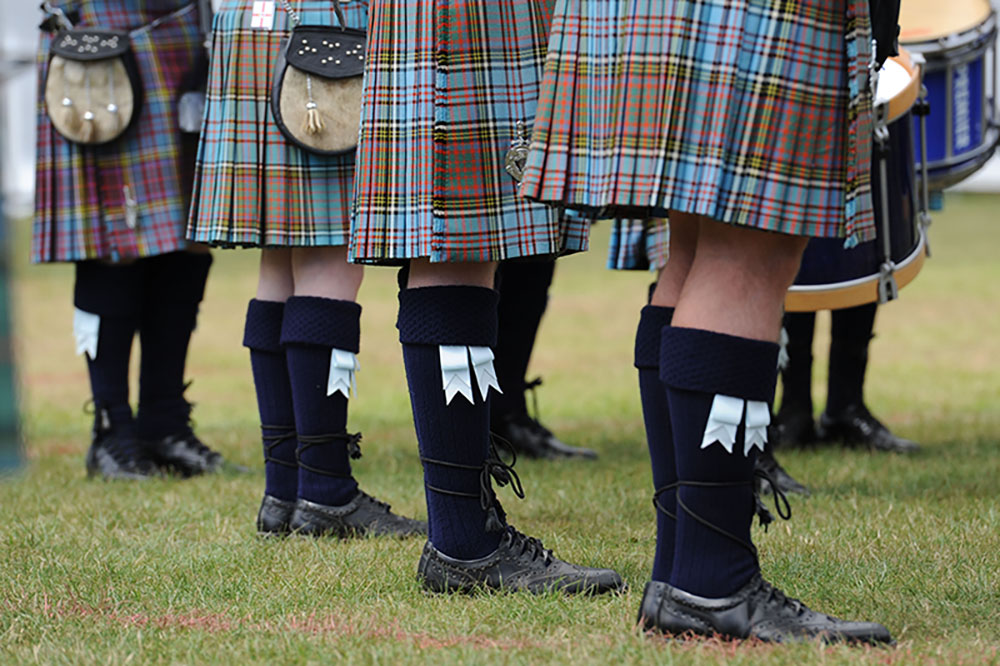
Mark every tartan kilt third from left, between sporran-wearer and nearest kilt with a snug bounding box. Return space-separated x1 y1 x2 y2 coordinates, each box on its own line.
350 0 589 263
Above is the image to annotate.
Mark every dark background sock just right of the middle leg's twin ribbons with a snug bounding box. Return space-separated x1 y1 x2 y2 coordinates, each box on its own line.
490 259 556 423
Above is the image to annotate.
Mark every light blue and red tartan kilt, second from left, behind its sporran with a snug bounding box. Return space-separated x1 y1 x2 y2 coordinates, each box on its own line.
187 0 368 247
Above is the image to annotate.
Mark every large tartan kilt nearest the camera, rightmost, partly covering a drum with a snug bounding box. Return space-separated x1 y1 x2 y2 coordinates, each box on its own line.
521 0 874 243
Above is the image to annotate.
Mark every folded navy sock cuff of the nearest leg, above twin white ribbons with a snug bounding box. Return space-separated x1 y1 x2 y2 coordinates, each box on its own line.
660 326 779 403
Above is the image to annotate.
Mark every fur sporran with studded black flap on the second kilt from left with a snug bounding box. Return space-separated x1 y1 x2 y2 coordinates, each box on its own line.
271 3 366 155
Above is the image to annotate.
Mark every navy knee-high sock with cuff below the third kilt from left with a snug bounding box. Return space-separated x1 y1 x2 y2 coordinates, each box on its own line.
397 286 503 559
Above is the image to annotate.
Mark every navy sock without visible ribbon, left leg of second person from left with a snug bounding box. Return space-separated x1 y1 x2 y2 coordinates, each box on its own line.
243 299 299 502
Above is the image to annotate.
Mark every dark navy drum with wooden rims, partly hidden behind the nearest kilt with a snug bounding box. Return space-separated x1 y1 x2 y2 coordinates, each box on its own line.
785 49 929 312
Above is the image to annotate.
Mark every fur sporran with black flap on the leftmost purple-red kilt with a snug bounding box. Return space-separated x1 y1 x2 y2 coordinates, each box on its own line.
45 28 142 145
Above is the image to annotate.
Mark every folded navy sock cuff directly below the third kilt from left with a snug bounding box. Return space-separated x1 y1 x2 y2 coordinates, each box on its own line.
396 286 500 347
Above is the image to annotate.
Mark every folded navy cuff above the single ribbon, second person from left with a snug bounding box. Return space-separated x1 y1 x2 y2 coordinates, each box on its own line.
281 296 361 354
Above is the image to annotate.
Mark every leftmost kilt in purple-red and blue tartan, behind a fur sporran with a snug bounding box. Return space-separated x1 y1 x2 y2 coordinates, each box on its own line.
31 0 204 262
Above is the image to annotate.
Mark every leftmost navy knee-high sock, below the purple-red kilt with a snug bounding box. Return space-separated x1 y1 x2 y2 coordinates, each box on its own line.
73 261 142 428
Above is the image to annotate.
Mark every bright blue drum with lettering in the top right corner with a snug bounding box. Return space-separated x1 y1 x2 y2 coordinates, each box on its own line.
899 0 1000 190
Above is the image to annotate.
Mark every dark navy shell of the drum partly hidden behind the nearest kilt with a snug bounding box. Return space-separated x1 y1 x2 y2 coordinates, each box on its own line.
788 111 921 311
